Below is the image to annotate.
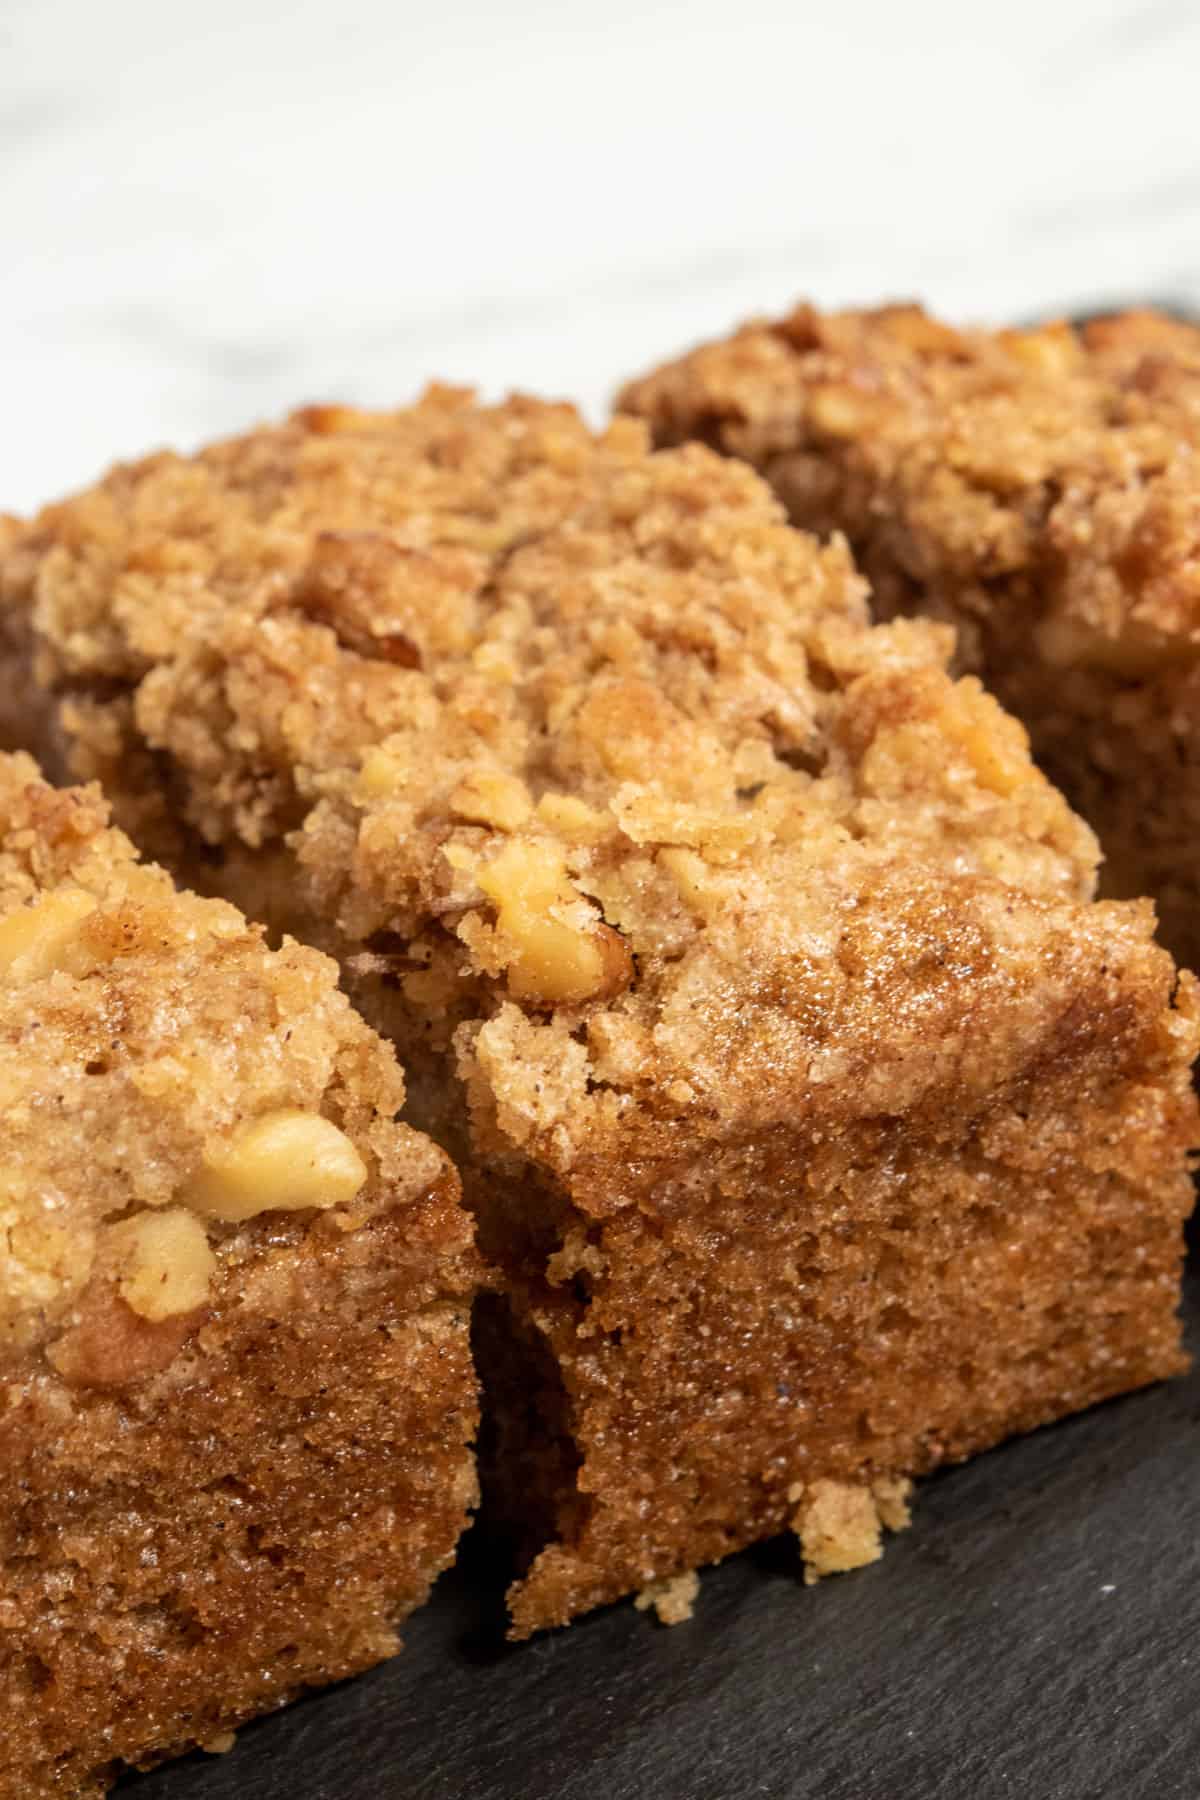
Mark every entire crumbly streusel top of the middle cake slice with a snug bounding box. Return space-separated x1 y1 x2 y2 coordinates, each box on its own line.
4 389 1194 1163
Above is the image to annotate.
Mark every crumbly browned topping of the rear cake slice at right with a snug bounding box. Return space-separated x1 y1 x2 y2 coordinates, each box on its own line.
621 306 1200 675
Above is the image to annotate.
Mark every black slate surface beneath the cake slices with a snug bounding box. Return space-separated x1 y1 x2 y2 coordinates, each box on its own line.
119 1258 1200 1800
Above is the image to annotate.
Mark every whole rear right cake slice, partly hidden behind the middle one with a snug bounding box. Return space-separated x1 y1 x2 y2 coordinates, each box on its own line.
621 306 1200 967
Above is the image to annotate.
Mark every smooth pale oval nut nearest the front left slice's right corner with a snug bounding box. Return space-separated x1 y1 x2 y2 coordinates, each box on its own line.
187 1107 367 1222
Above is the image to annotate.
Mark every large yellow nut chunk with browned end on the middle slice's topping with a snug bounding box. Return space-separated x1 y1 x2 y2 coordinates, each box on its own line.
479 842 633 1006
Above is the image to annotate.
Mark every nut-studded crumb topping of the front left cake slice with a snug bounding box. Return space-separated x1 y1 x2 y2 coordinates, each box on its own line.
0 756 470 1384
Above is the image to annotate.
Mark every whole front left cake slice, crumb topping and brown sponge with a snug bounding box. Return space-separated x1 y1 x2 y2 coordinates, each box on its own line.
0 756 477 1800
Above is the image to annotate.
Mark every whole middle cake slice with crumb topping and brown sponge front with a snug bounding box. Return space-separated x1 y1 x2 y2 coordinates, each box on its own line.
5 391 1198 1634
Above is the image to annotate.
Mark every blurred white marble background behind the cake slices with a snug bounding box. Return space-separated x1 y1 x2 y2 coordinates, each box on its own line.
0 0 1200 509
